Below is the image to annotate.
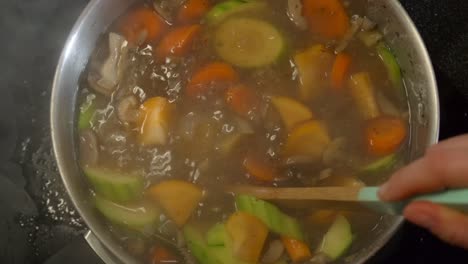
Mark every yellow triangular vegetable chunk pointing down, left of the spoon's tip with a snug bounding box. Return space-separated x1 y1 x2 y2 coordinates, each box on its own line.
148 180 203 227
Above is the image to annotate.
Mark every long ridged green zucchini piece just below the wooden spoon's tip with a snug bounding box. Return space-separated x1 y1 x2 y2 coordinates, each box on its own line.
236 195 304 241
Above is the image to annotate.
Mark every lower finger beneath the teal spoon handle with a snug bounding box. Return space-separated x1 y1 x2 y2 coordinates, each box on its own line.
403 202 468 249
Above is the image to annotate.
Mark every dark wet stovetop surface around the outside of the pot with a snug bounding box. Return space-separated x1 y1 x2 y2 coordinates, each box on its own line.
0 0 468 264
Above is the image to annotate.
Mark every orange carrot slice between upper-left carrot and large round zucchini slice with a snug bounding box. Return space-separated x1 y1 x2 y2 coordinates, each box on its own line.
156 25 200 58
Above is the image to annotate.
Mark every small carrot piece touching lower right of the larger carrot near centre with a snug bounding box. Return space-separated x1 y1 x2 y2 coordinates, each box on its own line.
226 85 260 117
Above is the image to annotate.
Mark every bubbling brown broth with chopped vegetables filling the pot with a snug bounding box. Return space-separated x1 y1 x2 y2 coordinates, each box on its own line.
77 0 409 263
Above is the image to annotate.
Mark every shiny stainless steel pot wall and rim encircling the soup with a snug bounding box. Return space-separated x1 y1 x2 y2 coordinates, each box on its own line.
51 0 439 263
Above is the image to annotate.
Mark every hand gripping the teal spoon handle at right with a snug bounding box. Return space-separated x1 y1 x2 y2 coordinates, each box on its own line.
379 135 468 249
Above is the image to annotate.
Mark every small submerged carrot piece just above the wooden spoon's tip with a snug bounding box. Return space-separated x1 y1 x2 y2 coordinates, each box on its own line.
244 153 277 182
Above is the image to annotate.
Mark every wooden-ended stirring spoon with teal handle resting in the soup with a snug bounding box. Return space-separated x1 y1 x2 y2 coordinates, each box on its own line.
229 185 468 215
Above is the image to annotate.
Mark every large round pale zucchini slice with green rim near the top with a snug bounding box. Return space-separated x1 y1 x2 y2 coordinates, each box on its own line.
214 17 285 68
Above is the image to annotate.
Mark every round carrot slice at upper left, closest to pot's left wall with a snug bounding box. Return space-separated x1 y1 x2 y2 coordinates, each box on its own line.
119 7 167 45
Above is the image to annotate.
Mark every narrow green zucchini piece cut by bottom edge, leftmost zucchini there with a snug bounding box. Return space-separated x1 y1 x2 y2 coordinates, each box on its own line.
184 226 223 264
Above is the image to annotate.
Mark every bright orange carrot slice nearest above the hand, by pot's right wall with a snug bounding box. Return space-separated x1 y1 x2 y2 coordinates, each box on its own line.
365 116 407 155
